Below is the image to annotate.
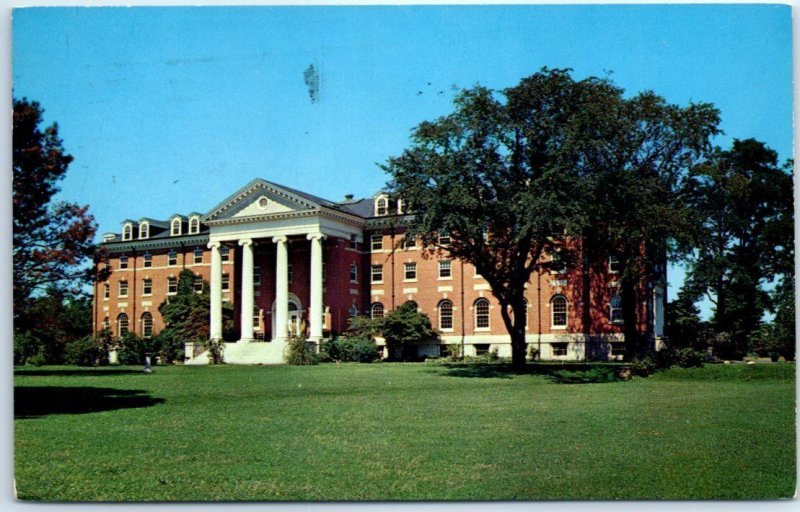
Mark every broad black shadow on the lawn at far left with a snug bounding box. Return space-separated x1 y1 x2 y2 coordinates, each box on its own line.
14 386 164 419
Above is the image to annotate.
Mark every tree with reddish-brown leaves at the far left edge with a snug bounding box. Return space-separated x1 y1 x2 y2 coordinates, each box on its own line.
12 99 97 316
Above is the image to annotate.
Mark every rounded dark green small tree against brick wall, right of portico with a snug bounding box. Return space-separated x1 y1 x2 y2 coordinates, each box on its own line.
381 303 439 360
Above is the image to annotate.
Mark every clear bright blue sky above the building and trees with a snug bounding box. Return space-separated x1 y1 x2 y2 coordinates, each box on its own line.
12 4 793 316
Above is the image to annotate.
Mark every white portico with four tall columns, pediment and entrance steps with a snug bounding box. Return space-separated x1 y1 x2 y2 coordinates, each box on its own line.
195 180 363 363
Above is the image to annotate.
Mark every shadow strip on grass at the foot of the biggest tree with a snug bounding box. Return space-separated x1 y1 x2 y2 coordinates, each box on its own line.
432 363 619 384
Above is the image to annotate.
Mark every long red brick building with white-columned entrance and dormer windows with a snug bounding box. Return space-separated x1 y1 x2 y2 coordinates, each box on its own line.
94 179 665 363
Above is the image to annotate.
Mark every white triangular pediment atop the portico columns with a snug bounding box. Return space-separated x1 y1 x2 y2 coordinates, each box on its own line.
205 179 321 221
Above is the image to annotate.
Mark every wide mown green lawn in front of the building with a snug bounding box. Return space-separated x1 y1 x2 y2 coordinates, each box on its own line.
15 363 796 501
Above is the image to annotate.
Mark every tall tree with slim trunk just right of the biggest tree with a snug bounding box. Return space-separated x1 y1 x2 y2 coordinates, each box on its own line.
579 91 719 359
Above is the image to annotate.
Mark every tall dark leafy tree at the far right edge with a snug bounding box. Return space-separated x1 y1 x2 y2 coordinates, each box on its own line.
689 139 794 355
